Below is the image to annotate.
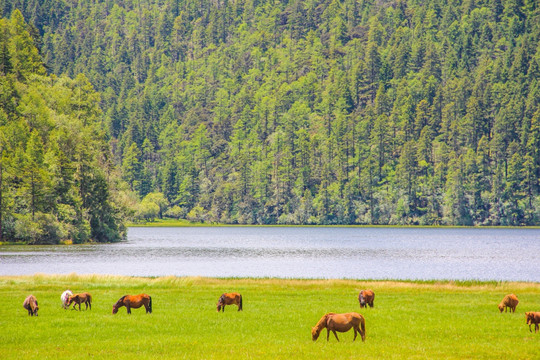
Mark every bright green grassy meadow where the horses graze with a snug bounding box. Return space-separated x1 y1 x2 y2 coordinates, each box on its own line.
0 274 540 359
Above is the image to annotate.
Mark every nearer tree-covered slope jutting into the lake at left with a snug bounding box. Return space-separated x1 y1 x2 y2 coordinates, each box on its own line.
0 10 125 244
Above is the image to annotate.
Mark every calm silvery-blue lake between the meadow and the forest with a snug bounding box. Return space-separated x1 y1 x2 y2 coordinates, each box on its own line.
0 227 540 282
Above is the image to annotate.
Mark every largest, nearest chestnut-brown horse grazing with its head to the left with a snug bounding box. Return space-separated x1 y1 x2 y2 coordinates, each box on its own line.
311 313 366 341
